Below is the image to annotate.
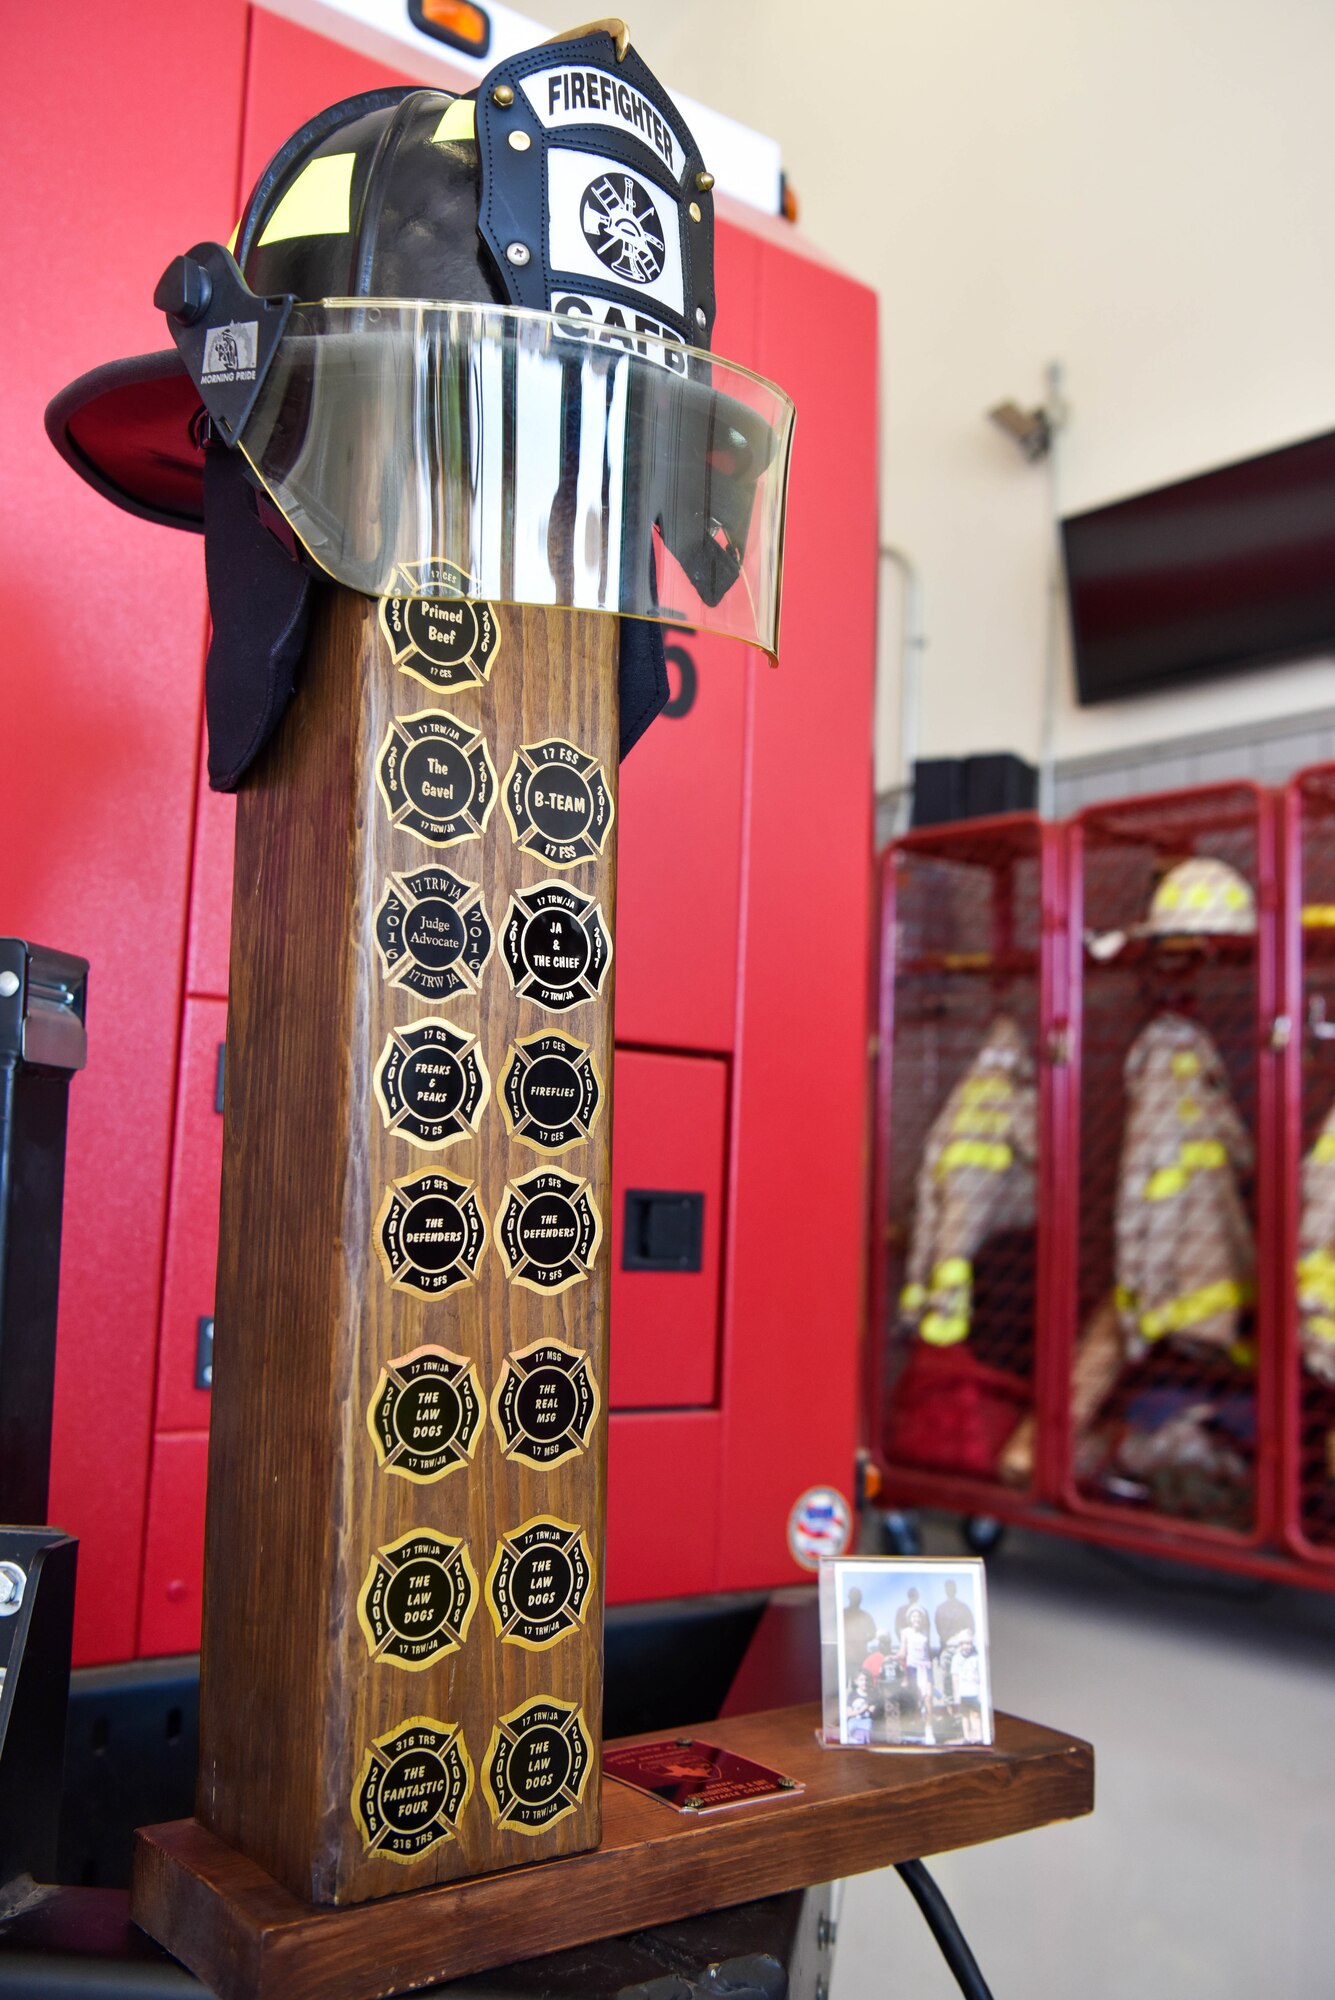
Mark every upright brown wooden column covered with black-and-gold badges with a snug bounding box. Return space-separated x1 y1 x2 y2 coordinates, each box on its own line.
184 590 618 1904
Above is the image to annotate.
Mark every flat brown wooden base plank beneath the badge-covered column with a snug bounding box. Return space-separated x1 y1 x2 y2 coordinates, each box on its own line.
130 1704 1093 2000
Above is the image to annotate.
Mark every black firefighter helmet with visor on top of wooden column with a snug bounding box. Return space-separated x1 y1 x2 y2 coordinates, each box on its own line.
48 24 791 788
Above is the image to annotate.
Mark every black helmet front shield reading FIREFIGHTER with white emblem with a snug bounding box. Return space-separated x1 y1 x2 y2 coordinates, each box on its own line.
478 30 713 348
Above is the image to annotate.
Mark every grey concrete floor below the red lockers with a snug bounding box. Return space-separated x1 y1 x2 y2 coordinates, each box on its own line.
831 1526 1335 2000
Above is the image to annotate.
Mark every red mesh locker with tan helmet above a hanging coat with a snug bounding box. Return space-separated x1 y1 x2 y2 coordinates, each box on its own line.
1061 784 1279 1554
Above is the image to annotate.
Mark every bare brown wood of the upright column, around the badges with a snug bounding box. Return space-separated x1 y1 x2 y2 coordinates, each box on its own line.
198 590 618 1904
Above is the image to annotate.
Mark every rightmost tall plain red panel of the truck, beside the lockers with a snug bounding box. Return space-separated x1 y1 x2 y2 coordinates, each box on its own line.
715 222 877 1590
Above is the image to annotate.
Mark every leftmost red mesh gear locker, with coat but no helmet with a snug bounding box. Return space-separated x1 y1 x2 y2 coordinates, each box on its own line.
869 814 1065 1516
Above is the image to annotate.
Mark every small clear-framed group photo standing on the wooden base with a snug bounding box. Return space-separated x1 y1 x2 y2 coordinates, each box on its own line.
819 1556 991 1750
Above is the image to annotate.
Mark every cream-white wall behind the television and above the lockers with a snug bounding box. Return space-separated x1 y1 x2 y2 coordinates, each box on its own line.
526 0 1335 784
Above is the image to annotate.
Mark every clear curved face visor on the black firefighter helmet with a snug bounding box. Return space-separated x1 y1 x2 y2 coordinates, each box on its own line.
240 298 793 658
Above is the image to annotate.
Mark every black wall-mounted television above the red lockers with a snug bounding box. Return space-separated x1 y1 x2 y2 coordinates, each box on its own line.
1061 432 1335 706
